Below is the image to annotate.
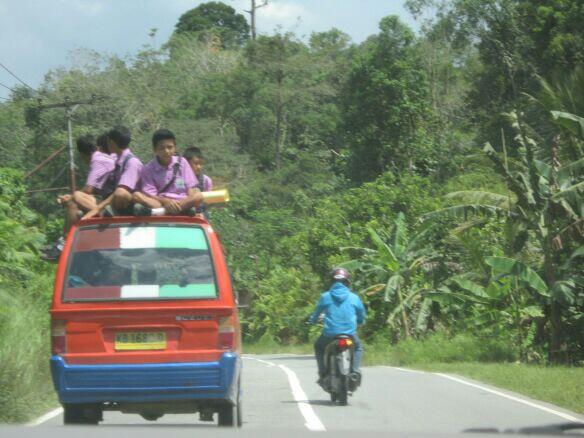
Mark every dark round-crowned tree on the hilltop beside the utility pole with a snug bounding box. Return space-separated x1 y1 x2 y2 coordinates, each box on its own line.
175 2 249 47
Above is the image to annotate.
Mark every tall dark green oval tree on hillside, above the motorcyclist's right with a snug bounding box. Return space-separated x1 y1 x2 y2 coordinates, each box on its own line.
341 16 428 183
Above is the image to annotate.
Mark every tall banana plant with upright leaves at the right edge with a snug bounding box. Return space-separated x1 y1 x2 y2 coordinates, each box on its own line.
423 111 584 360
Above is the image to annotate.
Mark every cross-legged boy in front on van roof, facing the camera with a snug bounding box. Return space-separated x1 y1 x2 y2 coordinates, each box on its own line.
133 129 203 216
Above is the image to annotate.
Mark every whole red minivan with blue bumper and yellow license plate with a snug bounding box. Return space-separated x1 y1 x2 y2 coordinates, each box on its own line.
50 217 241 426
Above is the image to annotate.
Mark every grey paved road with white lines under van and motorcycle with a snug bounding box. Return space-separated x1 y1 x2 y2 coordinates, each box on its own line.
36 355 584 434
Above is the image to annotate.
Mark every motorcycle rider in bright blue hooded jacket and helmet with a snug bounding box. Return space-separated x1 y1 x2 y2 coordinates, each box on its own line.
310 268 365 386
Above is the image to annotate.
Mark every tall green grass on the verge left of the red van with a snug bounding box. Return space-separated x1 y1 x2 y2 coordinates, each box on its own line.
0 168 53 423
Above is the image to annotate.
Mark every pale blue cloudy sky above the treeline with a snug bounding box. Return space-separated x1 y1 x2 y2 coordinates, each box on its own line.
0 0 417 98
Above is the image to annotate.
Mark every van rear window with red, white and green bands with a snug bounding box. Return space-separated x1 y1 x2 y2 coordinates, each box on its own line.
63 225 217 301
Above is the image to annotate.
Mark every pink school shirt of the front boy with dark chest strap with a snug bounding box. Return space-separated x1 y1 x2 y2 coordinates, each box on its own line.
142 156 199 200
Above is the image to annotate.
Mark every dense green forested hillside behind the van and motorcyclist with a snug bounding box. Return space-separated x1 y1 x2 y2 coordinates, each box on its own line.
0 5 584 416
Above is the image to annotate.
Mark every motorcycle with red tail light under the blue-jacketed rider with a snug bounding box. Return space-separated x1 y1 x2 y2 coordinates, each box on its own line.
322 335 361 406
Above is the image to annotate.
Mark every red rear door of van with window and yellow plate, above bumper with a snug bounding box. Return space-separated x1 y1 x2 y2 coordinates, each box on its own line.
53 223 237 364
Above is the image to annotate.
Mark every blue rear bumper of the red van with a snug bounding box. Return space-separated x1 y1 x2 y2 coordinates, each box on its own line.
51 353 241 403
